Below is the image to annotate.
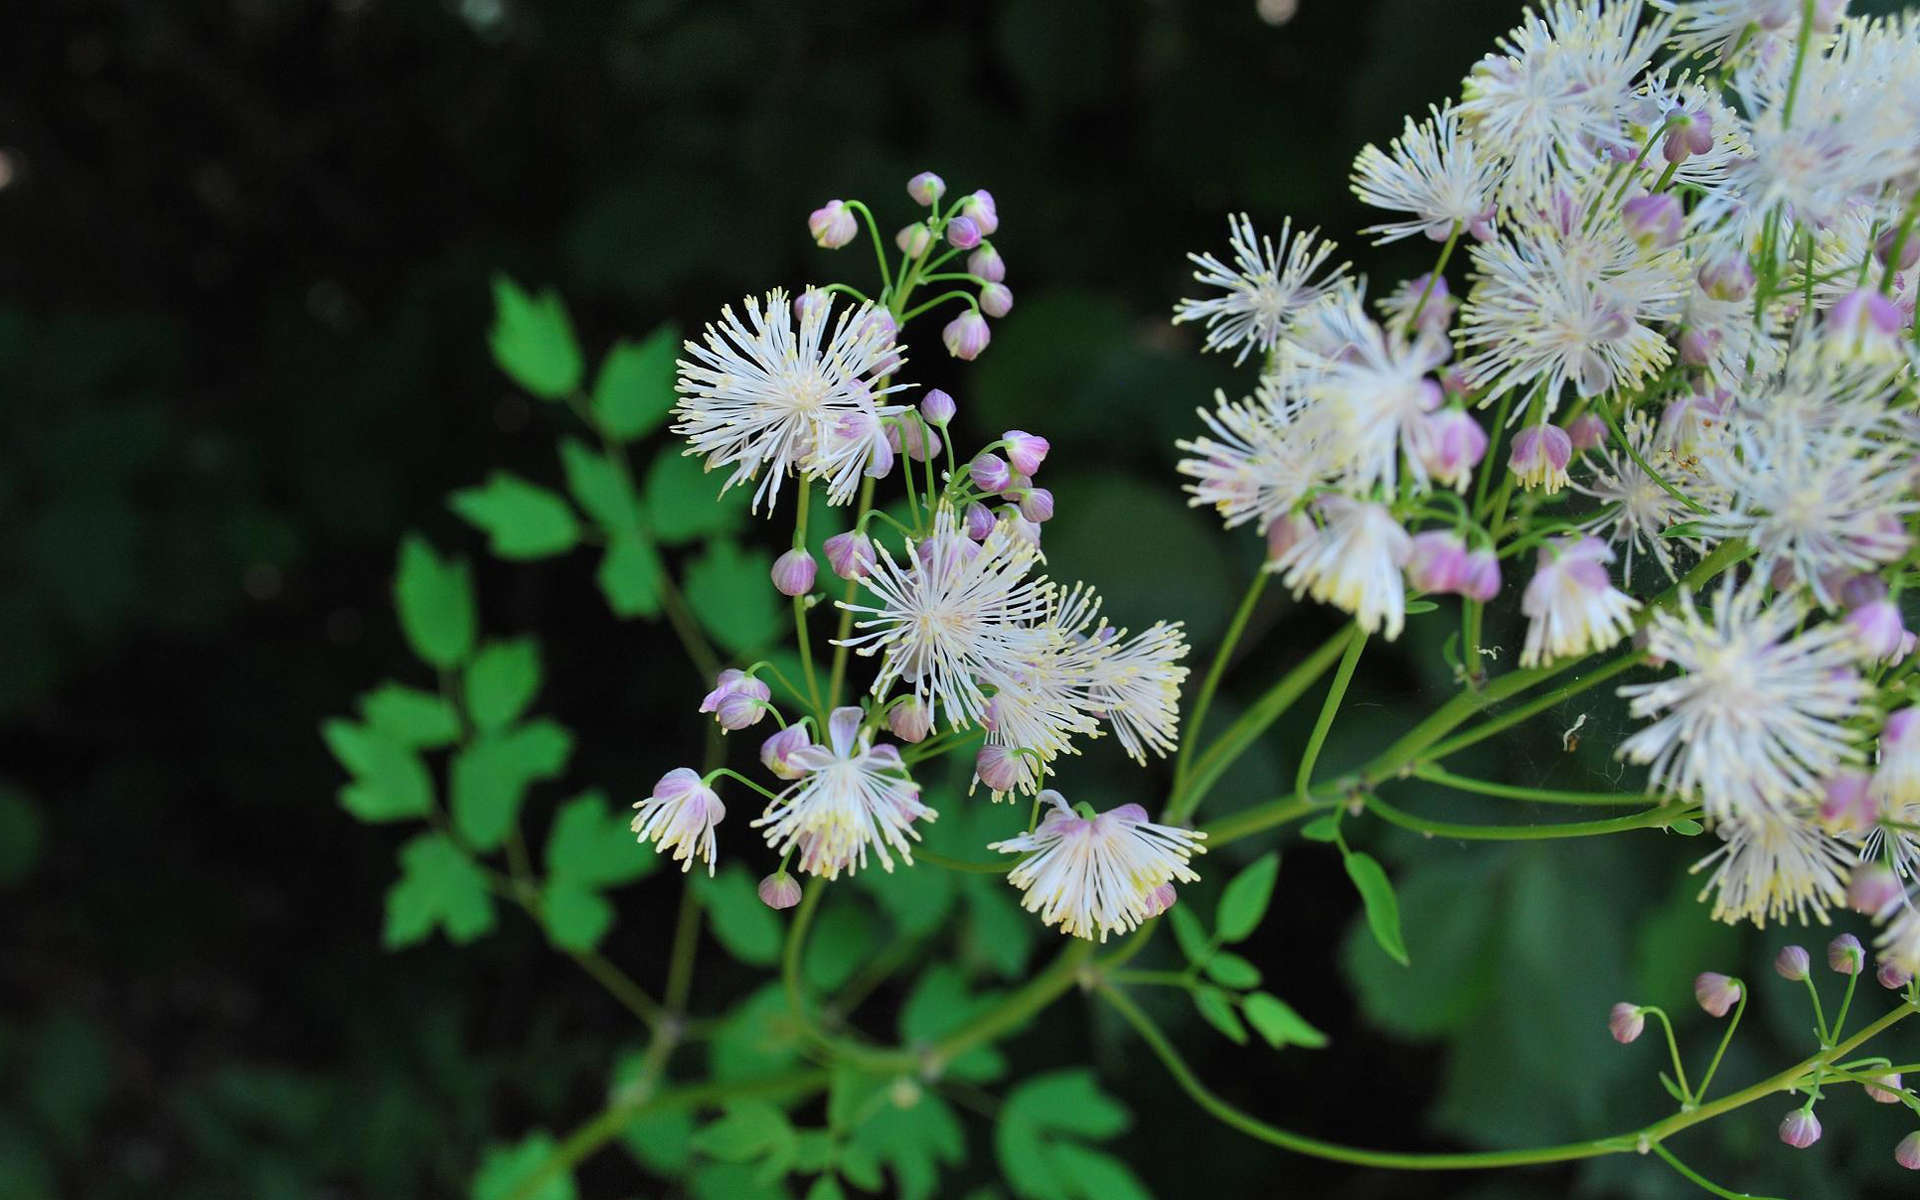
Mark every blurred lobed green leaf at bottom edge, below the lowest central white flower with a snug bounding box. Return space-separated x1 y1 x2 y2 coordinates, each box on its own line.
993 1069 1127 1200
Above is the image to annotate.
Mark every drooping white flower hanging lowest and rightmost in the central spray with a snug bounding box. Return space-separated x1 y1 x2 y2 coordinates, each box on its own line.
987 791 1206 941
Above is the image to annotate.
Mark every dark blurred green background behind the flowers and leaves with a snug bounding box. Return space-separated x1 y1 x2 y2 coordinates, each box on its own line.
11 0 1905 1200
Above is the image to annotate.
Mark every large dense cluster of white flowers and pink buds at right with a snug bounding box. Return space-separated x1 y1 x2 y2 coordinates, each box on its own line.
1175 0 1920 944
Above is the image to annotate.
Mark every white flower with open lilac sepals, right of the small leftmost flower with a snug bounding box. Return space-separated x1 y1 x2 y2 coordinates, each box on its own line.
753 708 937 879
